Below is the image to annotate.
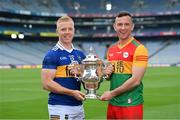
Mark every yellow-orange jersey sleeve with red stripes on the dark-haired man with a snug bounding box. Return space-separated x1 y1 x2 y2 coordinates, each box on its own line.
133 45 148 67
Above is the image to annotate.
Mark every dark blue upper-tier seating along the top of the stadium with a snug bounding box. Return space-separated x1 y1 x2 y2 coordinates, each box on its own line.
0 0 180 14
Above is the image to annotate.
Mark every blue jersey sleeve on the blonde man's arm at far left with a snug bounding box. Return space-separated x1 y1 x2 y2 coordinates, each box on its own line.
42 51 57 69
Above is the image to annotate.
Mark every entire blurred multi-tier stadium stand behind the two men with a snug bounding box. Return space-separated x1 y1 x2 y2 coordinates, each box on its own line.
0 0 180 66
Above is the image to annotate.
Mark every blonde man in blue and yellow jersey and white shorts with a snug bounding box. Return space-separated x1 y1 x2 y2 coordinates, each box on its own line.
41 16 85 120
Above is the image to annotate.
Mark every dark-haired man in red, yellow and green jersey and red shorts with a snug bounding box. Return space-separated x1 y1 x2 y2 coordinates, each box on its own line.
100 12 148 119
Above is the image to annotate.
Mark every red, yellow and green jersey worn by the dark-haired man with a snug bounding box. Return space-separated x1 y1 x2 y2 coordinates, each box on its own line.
107 37 148 106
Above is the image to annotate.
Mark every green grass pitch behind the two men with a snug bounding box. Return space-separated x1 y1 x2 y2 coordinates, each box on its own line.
0 67 180 120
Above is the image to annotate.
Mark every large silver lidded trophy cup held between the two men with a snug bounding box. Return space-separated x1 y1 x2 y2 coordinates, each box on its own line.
78 47 104 99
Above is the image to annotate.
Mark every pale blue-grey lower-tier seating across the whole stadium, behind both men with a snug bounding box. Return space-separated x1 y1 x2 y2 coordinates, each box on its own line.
0 38 180 64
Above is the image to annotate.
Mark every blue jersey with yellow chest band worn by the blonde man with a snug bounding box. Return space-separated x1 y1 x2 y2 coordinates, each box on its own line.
42 43 86 106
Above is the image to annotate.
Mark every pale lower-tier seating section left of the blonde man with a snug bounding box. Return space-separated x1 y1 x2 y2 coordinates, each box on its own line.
0 41 52 65
